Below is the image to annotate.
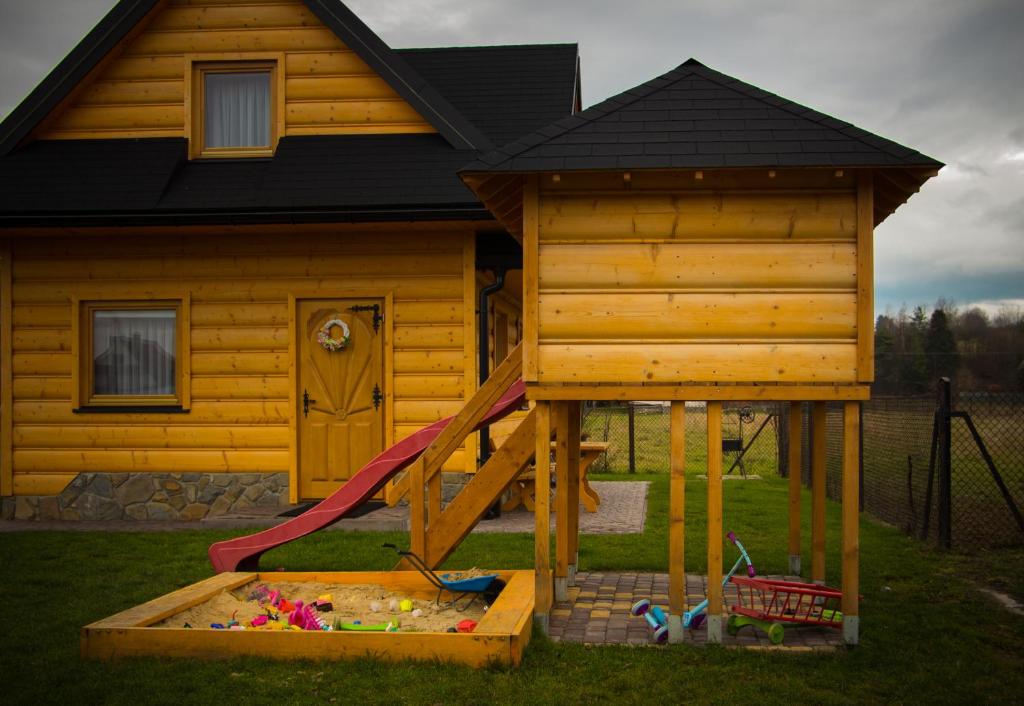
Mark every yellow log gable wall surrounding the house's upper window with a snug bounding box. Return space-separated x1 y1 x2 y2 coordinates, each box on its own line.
40 0 434 139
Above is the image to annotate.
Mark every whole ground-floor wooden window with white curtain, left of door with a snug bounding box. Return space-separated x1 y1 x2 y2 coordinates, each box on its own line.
75 299 188 411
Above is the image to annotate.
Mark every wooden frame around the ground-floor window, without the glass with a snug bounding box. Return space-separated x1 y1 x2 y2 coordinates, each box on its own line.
72 295 191 412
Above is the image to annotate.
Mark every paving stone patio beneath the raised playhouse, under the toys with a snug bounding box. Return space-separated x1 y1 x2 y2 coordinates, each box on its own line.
549 572 843 652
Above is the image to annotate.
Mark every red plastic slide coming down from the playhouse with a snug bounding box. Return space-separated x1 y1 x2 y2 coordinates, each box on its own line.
209 380 526 574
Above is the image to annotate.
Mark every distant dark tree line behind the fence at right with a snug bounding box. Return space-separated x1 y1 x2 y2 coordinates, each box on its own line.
873 299 1024 394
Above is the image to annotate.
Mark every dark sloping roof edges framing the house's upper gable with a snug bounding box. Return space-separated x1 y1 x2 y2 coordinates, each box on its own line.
0 0 494 155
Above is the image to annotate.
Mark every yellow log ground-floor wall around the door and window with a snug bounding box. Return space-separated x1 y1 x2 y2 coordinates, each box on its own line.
11 231 476 494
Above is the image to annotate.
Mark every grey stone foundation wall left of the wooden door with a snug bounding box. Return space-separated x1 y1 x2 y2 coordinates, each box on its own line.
0 473 289 521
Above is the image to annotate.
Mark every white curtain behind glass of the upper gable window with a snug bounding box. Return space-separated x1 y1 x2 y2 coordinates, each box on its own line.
204 72 270 148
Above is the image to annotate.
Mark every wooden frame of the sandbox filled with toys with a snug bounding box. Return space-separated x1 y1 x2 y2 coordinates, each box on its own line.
81 571 535 667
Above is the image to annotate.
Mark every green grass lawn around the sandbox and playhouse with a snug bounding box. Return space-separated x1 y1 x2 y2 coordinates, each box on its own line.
0 473 1024 704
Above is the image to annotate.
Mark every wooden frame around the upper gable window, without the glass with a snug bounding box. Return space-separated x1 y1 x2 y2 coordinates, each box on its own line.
185 52 285 160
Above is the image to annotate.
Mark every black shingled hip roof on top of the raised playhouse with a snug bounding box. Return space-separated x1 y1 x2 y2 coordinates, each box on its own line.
463 58 942 172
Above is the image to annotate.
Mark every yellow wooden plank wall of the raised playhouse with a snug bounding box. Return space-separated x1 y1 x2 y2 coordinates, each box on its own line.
524 171 870 384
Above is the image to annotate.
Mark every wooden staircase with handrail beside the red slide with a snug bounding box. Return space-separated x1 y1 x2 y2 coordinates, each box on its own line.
391 343 537 569
